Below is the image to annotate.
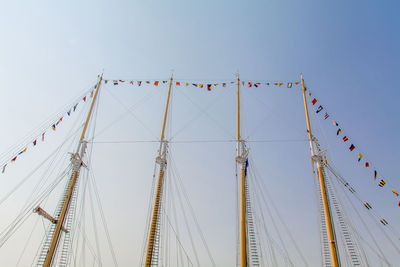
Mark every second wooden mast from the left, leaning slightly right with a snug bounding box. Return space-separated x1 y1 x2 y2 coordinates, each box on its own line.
144 76 172 267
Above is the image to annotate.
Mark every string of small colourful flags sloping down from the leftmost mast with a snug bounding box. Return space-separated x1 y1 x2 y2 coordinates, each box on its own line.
0 86 96 176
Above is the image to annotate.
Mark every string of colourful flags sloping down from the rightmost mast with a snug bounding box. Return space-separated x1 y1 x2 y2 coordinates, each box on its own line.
308 91 400 207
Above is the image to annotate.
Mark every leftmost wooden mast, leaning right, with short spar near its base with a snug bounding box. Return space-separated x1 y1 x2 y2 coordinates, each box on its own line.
43 74 103 267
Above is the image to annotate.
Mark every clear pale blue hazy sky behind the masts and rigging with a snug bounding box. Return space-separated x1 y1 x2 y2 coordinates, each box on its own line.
0 0 400 266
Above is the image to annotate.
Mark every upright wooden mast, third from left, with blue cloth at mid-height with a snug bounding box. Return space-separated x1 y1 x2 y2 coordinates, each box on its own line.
236 74 247 267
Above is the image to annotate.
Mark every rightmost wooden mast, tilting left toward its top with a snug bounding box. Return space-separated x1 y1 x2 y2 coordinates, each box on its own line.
301 75 339 267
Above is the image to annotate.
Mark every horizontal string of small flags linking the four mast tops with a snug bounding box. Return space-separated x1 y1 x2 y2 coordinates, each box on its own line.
104 80 300 91
